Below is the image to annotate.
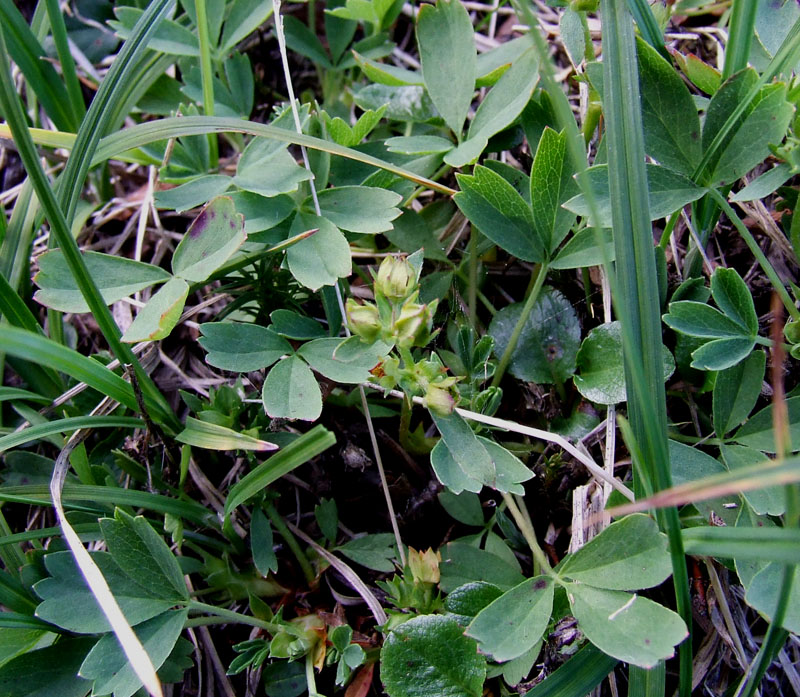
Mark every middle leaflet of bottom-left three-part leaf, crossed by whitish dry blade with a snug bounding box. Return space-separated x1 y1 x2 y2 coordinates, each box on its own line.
34 552 175 634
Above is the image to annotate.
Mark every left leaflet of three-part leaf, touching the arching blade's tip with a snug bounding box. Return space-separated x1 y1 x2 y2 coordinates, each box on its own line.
453 165 545 262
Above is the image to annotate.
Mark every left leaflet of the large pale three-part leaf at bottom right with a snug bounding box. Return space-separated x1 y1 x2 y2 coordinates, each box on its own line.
466 576 554 663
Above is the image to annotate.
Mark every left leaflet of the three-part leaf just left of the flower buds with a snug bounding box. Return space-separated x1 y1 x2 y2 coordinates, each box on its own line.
198 322 292 373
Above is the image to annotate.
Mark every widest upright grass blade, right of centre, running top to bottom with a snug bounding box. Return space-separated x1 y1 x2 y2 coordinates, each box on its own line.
601 0 692 697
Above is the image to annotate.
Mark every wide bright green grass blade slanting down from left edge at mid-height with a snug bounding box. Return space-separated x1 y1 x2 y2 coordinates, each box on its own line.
2 326 137 410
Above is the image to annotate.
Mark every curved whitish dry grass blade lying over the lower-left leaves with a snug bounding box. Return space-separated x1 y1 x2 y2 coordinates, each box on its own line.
50 400 163 697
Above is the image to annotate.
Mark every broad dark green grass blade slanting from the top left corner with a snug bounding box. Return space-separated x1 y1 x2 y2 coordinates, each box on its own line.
0 0 78 131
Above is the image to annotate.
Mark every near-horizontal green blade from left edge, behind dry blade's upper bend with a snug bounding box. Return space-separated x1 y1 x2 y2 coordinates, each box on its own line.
0 484 214 529
